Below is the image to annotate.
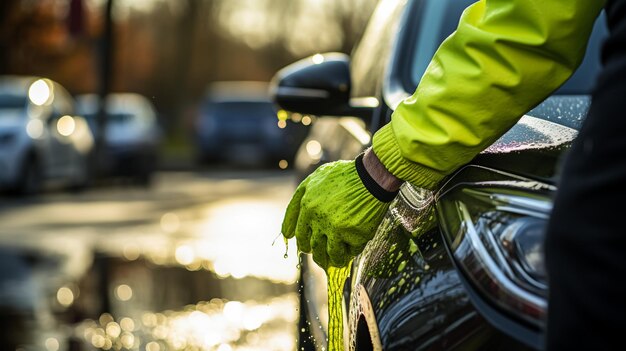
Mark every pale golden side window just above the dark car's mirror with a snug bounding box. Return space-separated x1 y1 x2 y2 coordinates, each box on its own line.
350 0 407 97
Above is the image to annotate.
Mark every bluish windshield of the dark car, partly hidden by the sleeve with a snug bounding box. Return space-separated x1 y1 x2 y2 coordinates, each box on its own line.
410 0 608 95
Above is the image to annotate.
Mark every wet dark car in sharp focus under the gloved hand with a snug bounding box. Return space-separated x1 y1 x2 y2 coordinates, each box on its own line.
272 0 606 350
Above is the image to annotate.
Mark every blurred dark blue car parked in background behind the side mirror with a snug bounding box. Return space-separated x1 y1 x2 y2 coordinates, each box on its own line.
194 82 307 168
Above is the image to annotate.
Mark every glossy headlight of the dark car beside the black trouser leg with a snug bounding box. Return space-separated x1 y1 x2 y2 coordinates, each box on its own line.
437 170 554 329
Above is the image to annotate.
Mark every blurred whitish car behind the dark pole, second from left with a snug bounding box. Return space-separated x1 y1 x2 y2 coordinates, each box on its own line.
76 93 162 185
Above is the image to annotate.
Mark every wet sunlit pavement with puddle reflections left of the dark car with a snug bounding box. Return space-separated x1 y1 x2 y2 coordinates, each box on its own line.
0 171 298 351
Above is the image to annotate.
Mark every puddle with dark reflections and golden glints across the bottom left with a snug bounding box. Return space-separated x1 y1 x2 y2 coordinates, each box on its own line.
0 247 298 351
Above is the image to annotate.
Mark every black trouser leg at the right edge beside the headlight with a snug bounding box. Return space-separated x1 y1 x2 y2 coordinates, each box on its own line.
546 6 626 350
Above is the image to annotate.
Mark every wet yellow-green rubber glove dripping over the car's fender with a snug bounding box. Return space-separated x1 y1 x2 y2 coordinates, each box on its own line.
282 155 397 269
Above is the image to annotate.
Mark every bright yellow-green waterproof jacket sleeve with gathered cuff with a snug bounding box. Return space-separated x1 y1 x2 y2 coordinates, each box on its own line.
373 0 604 189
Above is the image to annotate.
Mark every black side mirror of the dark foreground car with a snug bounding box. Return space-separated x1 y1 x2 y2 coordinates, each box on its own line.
270 53 373 118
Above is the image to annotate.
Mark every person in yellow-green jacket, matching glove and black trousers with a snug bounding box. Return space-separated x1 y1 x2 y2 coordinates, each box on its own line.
282 0 626 350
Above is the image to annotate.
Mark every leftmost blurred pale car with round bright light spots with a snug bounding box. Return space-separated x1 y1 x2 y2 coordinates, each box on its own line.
0 76 94 194
